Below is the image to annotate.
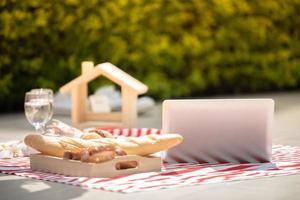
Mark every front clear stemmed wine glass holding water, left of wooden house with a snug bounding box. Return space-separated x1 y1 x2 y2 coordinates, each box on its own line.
24 91 53 134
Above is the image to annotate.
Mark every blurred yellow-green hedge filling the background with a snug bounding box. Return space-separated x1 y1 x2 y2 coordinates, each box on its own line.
0 0 300 111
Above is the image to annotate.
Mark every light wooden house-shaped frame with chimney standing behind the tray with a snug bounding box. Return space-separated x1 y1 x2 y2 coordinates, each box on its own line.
60 62 148 128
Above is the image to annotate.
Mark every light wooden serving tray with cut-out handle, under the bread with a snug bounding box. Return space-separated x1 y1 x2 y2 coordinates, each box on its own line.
30 154 161 178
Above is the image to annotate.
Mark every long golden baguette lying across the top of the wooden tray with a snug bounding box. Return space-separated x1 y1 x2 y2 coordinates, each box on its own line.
24 134 182 157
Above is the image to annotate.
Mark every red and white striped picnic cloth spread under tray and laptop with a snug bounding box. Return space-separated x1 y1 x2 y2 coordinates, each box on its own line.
0 129 300 193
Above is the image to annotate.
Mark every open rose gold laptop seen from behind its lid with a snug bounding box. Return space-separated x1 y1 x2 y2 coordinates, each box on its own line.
162 99 274 163
